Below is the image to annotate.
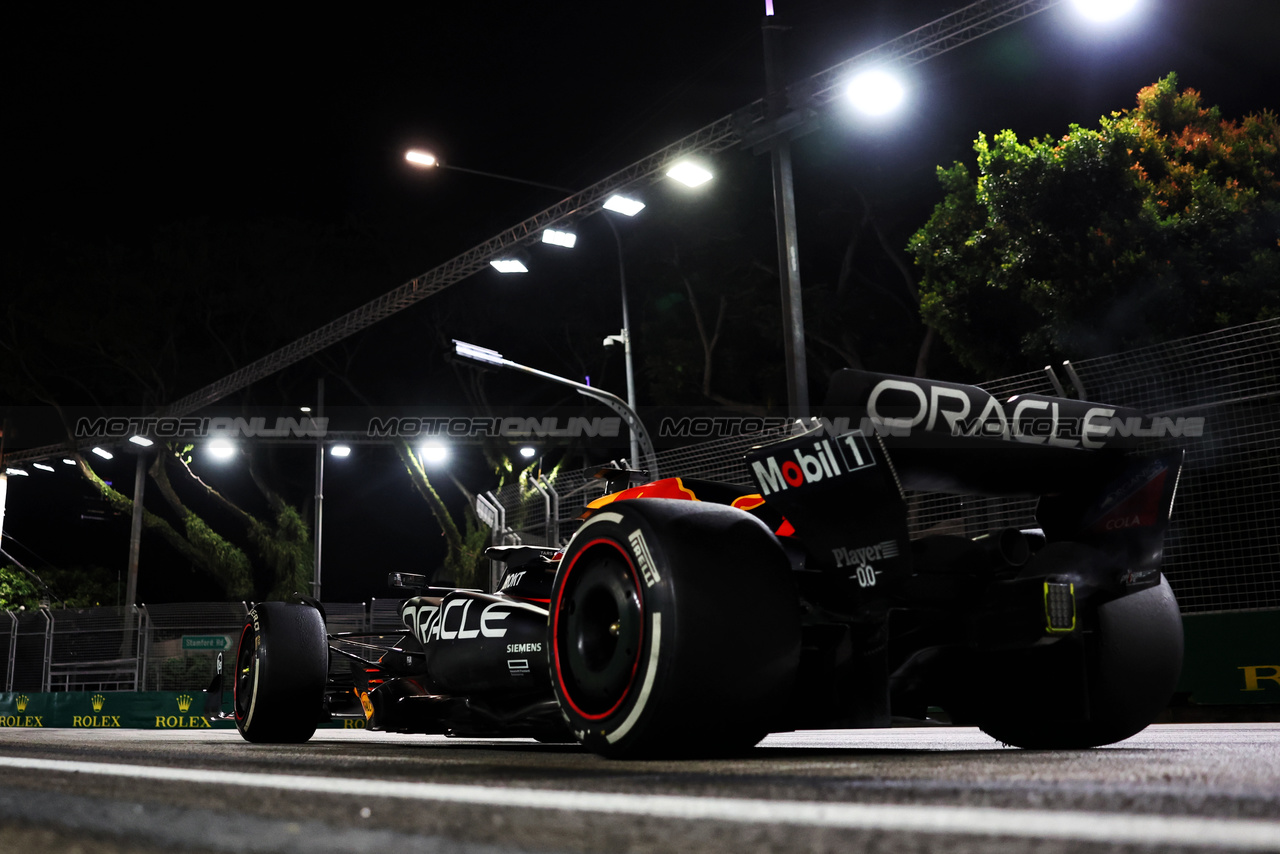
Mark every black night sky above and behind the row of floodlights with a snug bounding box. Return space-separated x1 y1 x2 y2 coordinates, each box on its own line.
0 0 1280 599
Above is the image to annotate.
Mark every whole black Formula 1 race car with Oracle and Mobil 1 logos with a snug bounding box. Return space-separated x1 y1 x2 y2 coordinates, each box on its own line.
209 370 1183 757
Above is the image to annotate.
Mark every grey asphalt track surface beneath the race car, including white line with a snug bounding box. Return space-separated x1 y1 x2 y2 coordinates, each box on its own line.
0 723 1280 854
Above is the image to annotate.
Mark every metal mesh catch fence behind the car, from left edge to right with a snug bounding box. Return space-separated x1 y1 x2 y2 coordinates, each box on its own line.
0 320 1280 691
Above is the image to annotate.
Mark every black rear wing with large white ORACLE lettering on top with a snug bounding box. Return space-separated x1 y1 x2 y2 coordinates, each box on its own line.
822 370 1182 578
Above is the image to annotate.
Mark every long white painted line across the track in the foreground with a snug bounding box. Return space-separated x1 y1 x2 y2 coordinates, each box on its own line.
0 757 1280 851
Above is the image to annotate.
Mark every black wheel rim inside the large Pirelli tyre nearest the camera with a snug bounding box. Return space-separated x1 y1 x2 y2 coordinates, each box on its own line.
552 539 644 720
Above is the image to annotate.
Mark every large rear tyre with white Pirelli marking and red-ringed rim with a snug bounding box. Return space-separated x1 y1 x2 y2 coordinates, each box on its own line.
548 498 800 758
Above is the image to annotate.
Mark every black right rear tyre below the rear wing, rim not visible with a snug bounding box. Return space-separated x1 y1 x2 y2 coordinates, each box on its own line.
980 543 1183 749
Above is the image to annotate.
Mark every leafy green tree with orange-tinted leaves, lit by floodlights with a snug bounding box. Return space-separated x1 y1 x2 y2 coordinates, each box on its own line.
909 74 1280 375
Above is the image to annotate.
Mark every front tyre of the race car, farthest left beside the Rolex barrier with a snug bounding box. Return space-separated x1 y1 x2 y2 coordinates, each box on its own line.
233 602 329 744
